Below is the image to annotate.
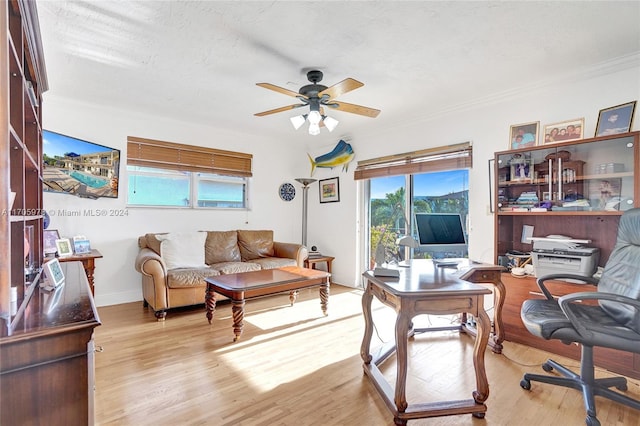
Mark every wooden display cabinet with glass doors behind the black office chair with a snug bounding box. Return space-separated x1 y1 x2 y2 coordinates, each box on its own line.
494 132 640 378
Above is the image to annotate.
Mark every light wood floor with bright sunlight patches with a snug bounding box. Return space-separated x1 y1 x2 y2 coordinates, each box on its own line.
95 285 640 426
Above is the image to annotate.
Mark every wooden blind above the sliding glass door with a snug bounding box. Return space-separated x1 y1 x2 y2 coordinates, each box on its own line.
354 142 473 180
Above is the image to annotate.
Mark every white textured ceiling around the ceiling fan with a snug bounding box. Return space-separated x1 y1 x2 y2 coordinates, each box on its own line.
38 0 640 141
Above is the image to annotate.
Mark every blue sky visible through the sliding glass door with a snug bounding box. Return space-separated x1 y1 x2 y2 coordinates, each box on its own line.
371 170 469 198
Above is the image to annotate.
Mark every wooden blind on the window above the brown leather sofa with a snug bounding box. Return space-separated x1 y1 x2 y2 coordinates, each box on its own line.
127 136 253 177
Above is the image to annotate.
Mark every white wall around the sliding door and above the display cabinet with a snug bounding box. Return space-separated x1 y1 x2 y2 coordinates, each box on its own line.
308 62 640 286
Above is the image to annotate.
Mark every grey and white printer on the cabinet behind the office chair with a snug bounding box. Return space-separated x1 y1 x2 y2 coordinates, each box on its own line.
529 235 600 277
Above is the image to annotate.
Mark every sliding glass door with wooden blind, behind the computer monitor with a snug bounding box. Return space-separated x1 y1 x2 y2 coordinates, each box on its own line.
356 144 472 268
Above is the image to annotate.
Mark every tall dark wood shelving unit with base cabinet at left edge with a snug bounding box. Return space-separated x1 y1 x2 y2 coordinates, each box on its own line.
0 0 100 425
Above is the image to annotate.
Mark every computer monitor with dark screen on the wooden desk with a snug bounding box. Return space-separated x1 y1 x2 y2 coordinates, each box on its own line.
416 213 467 258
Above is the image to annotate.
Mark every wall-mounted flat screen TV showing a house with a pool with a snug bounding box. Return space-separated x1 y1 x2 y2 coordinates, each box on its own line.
42 130 120 199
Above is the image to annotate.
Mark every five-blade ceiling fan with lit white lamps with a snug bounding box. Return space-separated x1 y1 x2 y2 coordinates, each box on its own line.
254 70 380 135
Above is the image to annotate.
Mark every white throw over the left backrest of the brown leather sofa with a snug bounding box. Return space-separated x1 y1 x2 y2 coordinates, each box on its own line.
156 232 207 270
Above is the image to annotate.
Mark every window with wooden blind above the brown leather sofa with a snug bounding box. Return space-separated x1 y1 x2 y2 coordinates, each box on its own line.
127 137 252 209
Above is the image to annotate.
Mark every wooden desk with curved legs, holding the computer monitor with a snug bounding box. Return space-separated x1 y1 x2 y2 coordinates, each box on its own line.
360 260 491 425
